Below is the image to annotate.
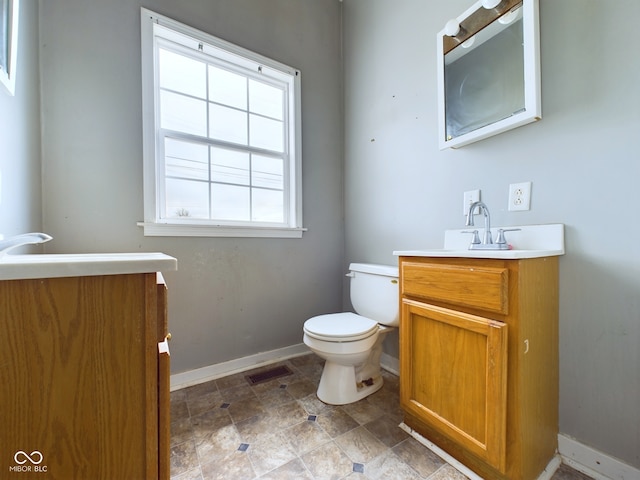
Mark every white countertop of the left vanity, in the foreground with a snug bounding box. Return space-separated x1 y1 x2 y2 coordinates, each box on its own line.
0 253 178 280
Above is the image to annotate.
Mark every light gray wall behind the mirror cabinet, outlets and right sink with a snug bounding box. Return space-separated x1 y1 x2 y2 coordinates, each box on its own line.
344 0 640 467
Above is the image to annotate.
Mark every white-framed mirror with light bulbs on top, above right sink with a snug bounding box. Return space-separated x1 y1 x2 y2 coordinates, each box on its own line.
437 0 542 150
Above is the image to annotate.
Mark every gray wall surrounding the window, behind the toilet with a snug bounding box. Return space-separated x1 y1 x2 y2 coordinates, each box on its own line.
39 0 344 373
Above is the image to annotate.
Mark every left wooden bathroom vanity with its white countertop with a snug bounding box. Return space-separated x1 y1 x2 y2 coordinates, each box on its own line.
0 253 177 480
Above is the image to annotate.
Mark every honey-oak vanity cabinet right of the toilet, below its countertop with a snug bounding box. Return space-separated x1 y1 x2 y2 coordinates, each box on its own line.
400 257 558 480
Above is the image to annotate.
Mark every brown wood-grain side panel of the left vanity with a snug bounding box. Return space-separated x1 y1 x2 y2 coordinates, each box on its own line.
0 275 157 479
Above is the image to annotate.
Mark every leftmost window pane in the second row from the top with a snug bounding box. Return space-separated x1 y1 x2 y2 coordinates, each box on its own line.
160 90 207 136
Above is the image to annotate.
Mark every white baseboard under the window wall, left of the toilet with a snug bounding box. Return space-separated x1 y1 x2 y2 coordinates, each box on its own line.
171 343 310 392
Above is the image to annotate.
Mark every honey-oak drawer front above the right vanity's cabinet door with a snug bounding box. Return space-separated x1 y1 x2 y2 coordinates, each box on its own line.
401 262 509 315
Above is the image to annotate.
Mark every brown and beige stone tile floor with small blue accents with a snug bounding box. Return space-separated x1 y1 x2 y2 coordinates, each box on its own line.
171 354 590 480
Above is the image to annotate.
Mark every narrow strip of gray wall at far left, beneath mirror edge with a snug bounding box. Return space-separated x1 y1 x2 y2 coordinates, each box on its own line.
0 1 42 238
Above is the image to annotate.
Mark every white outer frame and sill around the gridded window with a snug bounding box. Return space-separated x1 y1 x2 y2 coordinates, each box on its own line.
138 8 306 238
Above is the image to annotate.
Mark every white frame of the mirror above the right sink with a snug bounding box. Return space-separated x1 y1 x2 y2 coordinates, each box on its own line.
437 0 542 150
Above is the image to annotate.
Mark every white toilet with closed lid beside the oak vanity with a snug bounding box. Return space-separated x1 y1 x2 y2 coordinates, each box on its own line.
303 263 399 405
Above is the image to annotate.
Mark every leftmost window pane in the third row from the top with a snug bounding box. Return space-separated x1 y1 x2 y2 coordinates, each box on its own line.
164 138 209 180
